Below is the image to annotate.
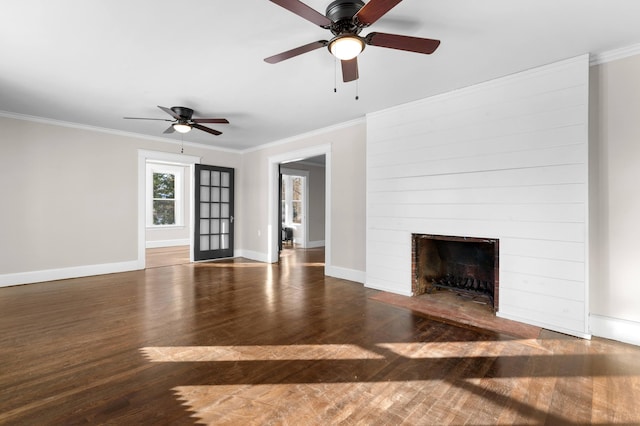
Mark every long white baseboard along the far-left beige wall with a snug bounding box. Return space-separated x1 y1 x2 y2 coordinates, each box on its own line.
0 260 144 287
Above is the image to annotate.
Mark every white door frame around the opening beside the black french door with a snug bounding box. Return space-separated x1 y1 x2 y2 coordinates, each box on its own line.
137 149 201 269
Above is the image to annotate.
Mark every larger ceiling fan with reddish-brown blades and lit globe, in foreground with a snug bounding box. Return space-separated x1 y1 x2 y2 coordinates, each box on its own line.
265 0 440 82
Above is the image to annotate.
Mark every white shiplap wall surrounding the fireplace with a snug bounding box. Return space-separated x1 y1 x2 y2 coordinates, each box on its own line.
366 55 589 337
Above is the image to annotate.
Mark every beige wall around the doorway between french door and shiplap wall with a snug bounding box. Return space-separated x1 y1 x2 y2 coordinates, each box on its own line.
240 122 366 274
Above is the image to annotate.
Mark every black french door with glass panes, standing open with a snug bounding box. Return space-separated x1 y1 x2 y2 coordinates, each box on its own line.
193 164 234 260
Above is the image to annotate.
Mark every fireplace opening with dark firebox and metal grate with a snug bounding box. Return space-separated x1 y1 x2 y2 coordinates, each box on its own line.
411 234 499 311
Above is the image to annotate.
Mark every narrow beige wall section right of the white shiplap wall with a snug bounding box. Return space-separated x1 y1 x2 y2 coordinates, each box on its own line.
590 55 640 322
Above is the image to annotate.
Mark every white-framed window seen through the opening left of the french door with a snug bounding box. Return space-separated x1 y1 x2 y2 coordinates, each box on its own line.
147 163 184 227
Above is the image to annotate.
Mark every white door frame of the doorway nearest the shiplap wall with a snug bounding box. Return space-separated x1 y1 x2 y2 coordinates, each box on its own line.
267 144 331 262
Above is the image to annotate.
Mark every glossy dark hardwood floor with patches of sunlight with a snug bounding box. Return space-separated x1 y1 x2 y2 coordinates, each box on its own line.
0 249 640 425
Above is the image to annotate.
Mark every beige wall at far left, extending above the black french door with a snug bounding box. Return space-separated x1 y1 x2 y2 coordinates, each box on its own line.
0 117 241 275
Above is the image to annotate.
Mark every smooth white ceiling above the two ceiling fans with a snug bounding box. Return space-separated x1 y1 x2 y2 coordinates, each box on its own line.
0 0 640 150
